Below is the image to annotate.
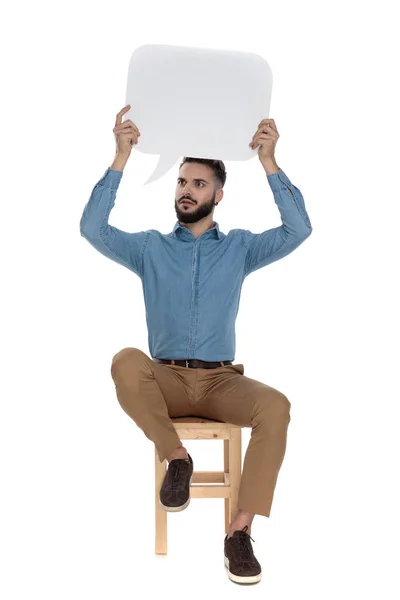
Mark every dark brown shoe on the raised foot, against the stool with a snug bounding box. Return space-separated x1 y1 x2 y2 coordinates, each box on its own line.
160 453 193 512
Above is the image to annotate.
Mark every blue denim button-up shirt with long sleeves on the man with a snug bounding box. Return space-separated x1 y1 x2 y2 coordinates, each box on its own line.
80 169 312 361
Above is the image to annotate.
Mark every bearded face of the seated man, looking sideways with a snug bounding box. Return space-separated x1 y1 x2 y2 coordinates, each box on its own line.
175 163 222 223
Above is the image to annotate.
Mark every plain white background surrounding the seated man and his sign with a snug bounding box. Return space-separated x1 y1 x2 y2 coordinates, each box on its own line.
0 1 400 600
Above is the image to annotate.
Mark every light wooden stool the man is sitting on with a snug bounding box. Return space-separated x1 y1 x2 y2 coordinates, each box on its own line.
155 417 242 554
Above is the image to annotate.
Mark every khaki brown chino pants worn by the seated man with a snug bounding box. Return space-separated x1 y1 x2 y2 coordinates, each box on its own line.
111 348 291 517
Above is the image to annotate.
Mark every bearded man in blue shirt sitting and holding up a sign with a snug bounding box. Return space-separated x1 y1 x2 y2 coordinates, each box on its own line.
80 105 312 583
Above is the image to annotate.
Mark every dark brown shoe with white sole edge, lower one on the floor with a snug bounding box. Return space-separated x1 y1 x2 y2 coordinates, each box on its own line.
224 525 261 583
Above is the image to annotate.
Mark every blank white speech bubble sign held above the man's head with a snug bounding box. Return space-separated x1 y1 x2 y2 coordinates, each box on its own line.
124 44 272 185
